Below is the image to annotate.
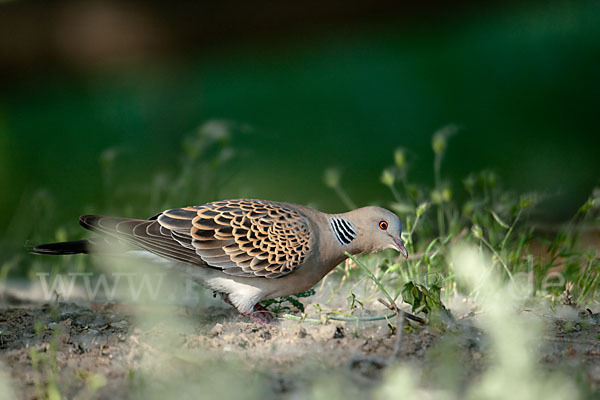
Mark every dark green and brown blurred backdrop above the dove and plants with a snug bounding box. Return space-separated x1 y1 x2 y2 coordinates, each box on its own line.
0 0 600 253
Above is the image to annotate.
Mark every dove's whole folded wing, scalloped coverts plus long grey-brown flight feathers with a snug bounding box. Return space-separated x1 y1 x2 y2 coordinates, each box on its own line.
80 200 314 278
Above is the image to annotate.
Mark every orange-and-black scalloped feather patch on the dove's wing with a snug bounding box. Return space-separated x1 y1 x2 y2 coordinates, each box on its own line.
157 200 314 278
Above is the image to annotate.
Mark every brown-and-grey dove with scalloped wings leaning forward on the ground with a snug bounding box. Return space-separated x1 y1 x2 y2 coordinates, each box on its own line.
32 199 408 324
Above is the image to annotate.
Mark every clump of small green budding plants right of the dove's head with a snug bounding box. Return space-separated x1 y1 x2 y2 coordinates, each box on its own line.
326 125 600 320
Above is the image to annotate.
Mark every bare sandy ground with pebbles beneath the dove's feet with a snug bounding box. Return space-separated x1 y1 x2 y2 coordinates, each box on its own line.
0 282 600 399
